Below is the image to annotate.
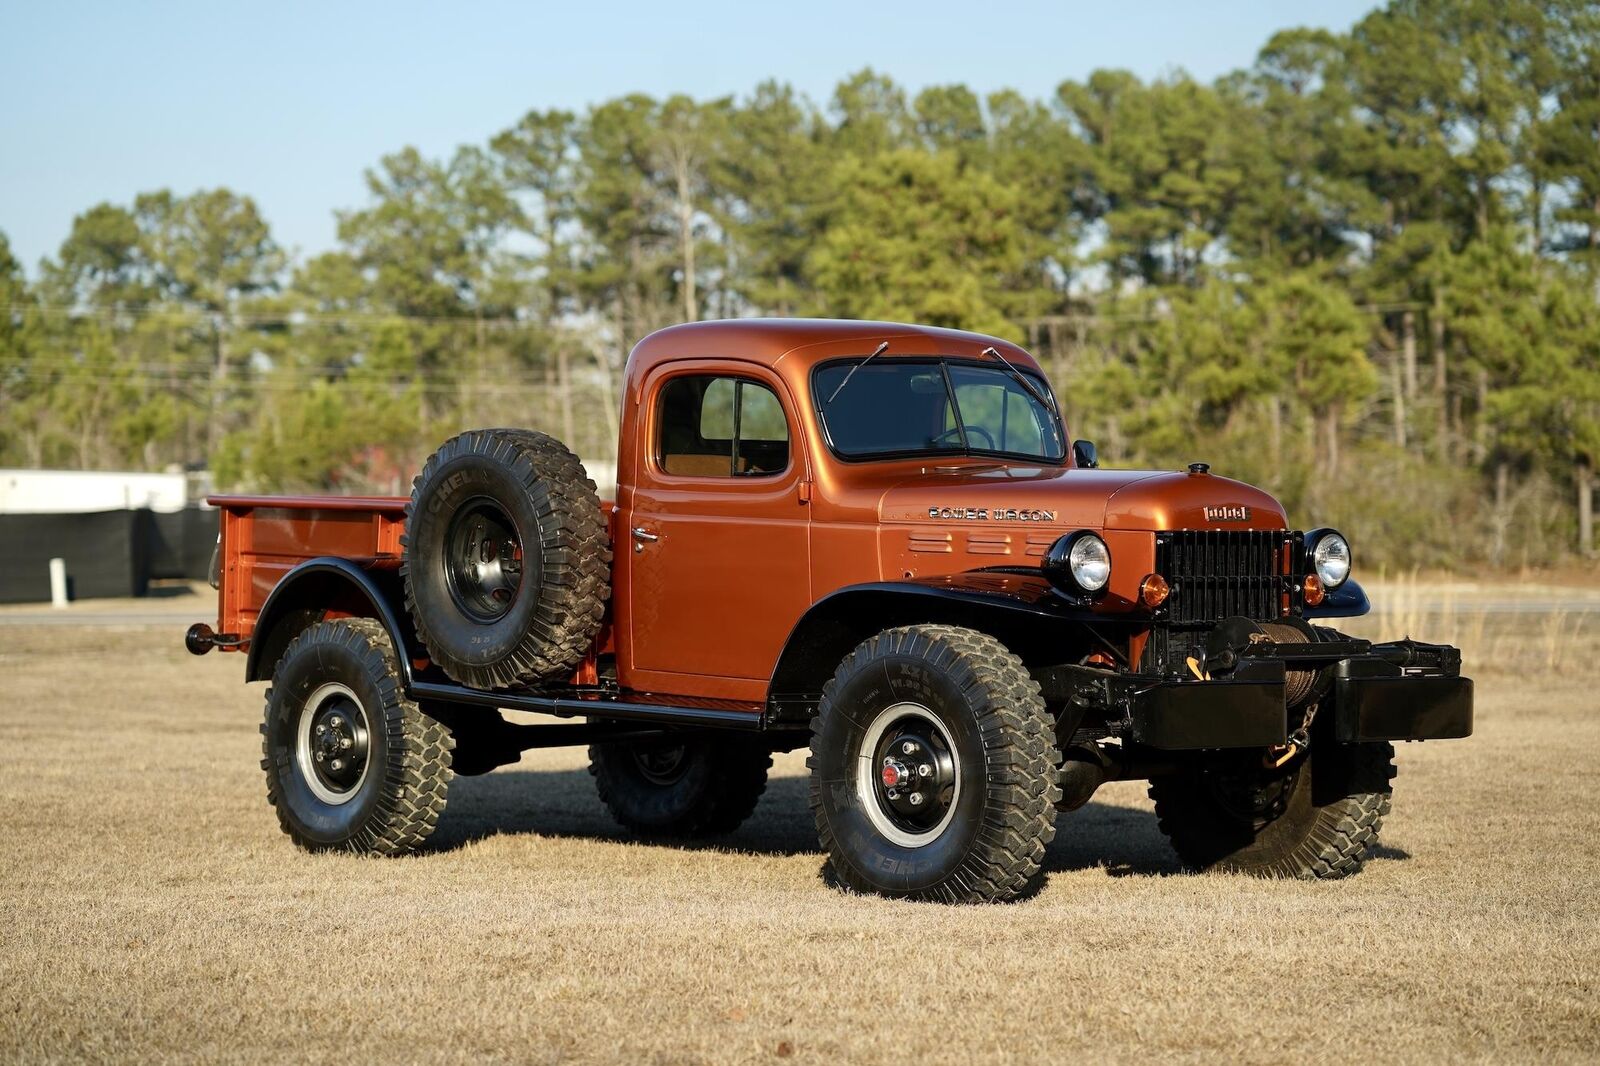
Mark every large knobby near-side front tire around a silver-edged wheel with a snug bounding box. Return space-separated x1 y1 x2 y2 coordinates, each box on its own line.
806 626 1061 903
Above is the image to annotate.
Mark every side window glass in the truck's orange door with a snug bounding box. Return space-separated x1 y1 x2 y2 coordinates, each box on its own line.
656 375 789 477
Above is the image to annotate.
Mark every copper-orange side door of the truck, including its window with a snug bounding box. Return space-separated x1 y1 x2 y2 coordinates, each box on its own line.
618 360 811 699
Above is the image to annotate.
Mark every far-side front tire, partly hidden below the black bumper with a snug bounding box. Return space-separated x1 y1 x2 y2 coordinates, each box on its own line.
1150 741 1395 880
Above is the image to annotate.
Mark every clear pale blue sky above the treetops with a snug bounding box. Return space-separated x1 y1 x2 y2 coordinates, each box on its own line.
0 0 1373 271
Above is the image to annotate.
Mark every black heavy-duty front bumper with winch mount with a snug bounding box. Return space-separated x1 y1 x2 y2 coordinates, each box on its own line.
1045 640 1472 751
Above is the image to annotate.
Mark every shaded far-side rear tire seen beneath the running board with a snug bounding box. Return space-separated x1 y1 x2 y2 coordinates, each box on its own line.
589 736 773 839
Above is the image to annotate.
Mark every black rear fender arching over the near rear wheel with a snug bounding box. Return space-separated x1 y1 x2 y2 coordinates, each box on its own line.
245 557 418 690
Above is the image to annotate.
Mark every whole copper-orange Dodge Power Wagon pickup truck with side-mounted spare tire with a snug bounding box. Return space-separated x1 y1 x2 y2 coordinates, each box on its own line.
187 313 1472 901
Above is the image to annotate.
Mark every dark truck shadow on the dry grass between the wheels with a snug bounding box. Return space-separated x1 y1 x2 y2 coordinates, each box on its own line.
426 768 1209 877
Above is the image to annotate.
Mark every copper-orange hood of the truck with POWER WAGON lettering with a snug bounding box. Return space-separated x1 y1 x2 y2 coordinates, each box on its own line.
878 466 1286 530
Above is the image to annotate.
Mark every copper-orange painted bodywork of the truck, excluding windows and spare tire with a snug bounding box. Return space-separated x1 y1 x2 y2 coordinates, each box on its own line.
216 320 1286 706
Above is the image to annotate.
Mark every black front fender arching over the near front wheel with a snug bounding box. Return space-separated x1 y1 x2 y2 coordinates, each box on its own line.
768 570 1120 706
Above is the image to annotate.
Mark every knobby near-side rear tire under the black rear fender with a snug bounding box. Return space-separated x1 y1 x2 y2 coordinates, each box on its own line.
261 618 454 855
